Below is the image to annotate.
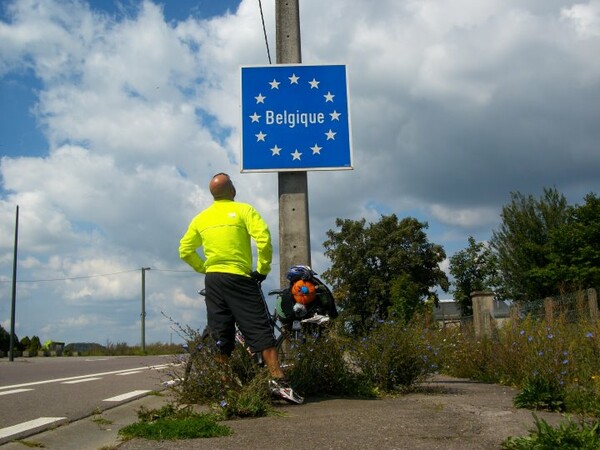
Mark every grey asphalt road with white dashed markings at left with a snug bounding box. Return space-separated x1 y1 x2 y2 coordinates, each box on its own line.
0 356 175 443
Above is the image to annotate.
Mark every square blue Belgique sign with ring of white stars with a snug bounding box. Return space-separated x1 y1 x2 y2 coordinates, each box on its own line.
242 65 352 172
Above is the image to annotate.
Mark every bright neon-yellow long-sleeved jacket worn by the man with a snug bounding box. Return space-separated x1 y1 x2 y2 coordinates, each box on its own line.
179 200 273 276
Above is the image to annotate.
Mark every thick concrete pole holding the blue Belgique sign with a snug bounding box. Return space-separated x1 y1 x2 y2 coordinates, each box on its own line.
275 0 311 286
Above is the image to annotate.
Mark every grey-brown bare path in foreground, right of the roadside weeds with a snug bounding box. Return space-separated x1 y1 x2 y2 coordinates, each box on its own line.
118 376 564 450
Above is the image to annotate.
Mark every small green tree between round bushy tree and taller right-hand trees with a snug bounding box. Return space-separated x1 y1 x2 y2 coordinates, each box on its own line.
450 236 499 316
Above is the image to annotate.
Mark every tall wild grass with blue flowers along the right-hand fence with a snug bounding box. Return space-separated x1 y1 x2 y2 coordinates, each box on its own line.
430 317 600 416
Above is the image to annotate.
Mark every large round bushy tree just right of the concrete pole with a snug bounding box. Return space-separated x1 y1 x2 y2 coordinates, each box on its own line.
323 214 448 334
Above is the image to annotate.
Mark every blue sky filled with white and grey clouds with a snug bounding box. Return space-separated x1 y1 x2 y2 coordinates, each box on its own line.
0 0 600 345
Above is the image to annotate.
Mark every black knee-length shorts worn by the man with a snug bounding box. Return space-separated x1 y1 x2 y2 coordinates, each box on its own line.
204 272 275 355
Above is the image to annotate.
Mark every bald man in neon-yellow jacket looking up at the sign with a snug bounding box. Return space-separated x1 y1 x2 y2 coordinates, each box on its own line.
179 173 303 403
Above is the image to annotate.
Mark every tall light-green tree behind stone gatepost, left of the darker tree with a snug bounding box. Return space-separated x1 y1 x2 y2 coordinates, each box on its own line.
490 188 569 301
